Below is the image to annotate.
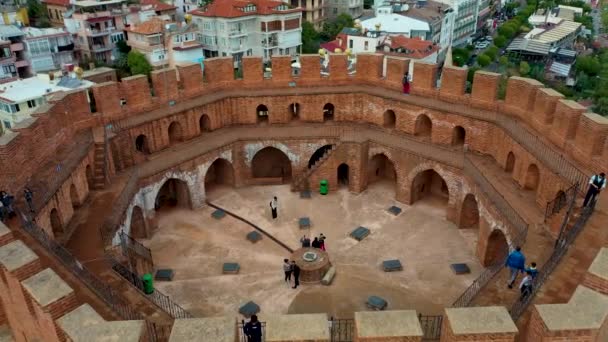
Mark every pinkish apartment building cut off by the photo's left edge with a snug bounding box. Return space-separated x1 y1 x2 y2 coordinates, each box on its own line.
0 25 31 83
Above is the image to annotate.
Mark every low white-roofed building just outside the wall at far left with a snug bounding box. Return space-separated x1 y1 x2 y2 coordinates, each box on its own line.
0 74 94 131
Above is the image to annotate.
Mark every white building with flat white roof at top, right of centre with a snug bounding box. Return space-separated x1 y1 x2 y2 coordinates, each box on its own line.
361 6 431 39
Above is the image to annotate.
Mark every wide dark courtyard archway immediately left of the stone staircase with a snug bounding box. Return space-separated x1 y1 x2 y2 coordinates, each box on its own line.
251 146 291 183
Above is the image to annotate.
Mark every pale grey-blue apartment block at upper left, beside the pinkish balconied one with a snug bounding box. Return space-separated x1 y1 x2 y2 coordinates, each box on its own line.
22 27 74 74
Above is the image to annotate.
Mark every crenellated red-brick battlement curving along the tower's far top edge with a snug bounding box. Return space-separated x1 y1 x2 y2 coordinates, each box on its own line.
0 54 608 195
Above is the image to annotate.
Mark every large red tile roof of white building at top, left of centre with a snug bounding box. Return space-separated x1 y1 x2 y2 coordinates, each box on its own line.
190 0 302 18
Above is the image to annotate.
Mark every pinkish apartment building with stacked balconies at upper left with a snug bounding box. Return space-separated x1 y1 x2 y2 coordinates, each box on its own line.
64 0 129 64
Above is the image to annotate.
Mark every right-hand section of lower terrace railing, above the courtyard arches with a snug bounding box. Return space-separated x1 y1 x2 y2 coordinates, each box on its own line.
464 154 528 246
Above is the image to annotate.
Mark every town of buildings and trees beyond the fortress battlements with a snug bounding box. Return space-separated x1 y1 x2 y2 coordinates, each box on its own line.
0 0 608 132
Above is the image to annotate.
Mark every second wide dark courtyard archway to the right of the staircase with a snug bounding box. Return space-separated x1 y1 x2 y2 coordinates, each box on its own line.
410 169 450 207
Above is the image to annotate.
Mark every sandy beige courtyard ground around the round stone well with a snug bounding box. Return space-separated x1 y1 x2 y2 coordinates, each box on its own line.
143 182 482 318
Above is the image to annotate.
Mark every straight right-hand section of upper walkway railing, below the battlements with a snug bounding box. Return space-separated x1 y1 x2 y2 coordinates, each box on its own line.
496 113 589 191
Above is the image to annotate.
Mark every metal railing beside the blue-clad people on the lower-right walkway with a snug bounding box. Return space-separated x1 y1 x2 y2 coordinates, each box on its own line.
509 198 595 321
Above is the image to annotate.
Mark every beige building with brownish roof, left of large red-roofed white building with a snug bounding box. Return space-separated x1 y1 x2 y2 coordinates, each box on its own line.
126 17 204 69
